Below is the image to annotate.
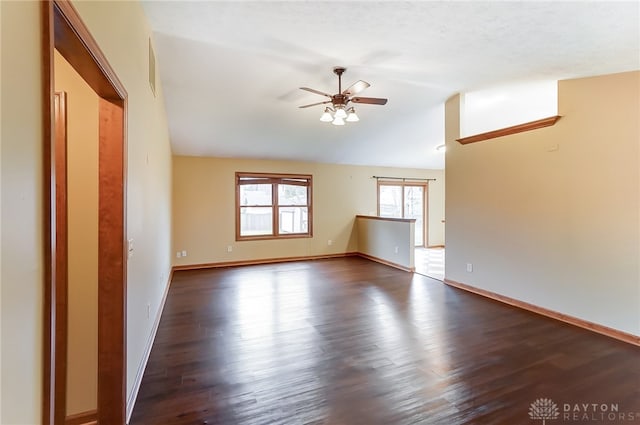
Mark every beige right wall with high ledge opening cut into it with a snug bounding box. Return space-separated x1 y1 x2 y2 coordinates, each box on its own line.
446 72 640 335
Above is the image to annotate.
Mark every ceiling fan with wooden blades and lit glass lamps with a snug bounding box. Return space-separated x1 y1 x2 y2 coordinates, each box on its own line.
299 66 387 125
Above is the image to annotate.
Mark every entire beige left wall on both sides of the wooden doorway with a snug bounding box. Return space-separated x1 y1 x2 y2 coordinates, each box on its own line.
0 1 171 424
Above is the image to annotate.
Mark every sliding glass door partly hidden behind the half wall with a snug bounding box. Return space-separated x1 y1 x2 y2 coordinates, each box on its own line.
378 181 427 246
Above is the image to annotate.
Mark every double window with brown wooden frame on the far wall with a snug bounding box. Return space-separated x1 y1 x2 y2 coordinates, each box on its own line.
236 173 312 240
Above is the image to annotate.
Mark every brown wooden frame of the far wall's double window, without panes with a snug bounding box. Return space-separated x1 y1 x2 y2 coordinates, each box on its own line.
235 171 313 241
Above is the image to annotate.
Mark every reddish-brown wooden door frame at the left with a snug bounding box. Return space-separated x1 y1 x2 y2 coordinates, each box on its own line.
41 0 127 425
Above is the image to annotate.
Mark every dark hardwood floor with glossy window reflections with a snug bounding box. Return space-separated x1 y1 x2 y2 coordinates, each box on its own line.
131 257 640 425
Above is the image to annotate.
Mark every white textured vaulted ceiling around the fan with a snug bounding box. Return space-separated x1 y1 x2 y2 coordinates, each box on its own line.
143 1 640 168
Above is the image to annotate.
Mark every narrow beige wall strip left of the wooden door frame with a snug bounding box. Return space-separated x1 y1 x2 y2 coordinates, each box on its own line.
0 1 43 424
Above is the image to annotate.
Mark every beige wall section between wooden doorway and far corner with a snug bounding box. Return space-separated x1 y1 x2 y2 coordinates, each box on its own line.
69 1 171 410
